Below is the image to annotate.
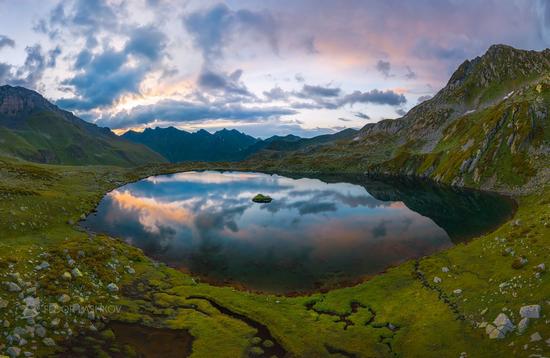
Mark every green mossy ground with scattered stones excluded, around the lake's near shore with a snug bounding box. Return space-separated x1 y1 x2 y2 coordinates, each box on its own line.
0 160 550 357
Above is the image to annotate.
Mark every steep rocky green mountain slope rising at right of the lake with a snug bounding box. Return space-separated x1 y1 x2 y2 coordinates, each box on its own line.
251 45 550 191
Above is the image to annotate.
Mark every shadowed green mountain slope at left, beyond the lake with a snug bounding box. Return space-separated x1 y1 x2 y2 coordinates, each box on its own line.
0 86 165 166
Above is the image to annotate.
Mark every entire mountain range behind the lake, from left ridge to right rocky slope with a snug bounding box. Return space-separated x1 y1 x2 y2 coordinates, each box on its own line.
0 45 550 193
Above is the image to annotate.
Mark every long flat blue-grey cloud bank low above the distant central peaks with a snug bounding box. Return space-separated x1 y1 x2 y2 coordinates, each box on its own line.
99 100 296 128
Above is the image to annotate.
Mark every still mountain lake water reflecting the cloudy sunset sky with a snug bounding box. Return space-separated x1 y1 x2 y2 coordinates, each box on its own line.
83 171 513 293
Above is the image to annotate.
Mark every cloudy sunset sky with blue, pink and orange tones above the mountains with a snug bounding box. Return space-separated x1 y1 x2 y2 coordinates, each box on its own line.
0 0 550 137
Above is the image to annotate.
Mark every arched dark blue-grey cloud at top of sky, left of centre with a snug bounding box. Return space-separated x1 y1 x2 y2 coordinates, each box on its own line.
183 4 278 63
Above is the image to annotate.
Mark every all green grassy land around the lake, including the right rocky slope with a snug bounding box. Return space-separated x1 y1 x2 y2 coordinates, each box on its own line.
0 46 550 357
